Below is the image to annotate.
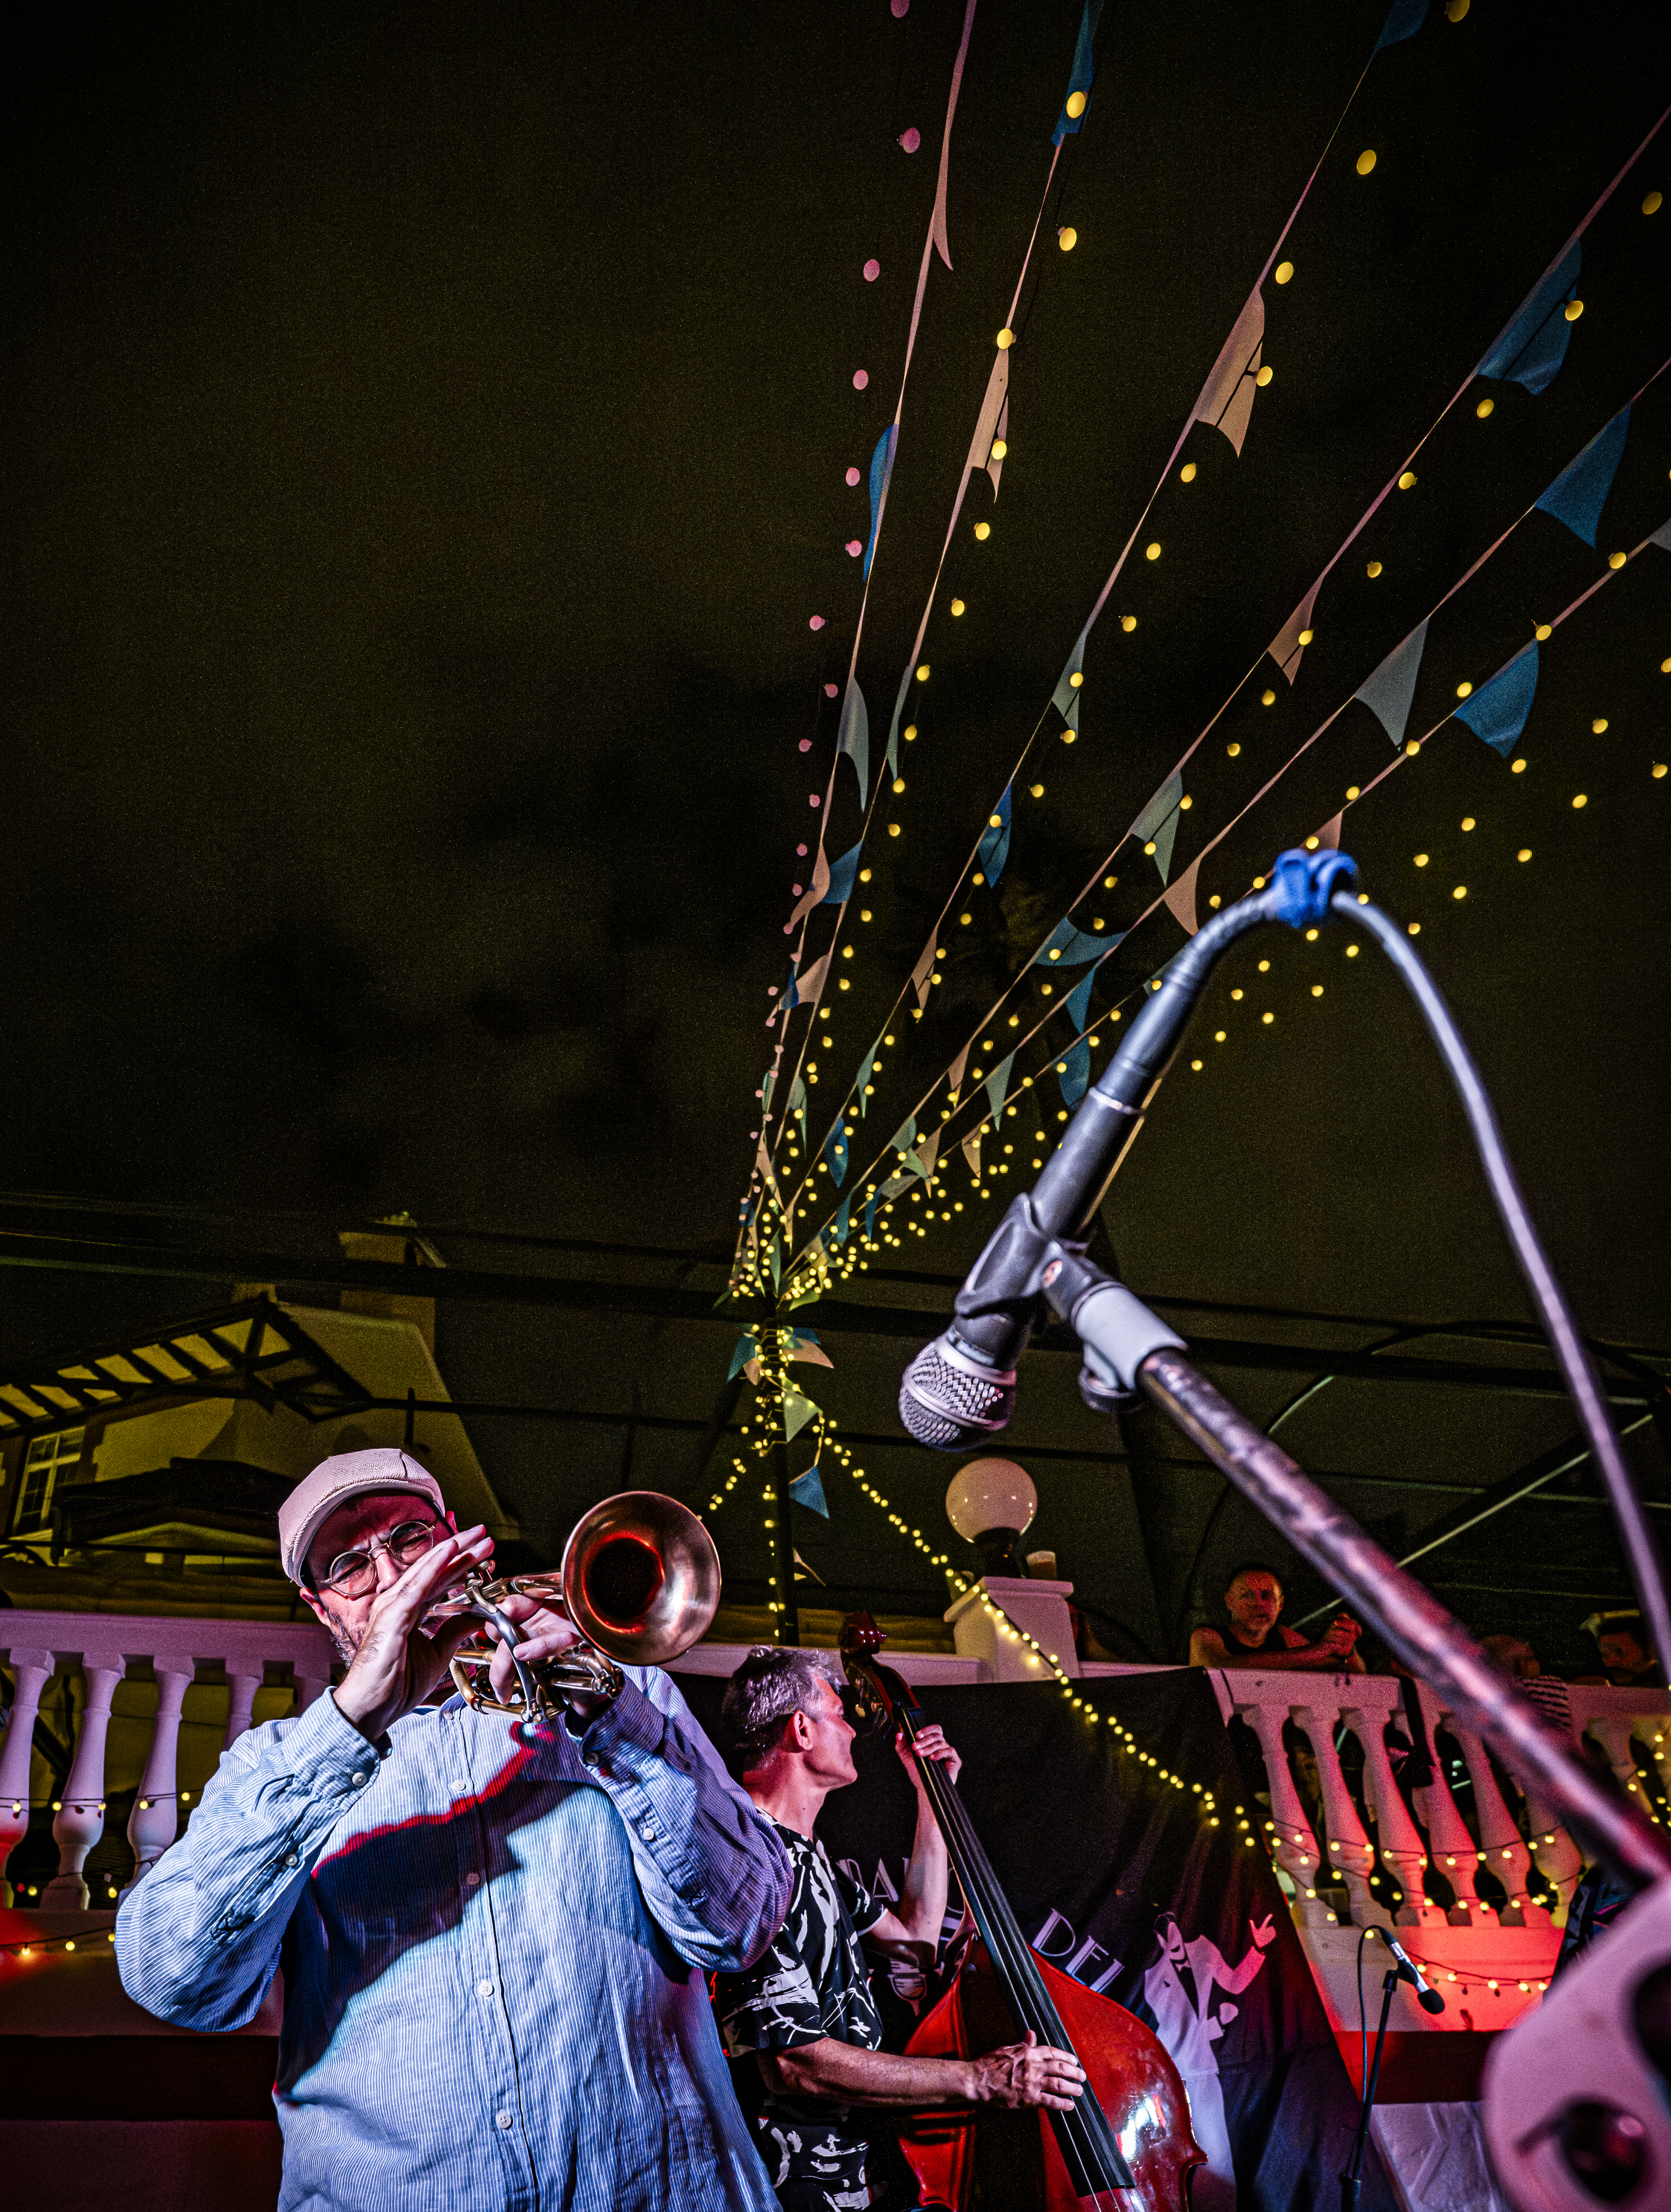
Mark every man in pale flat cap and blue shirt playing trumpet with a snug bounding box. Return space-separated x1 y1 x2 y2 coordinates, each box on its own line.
117 1449 791 2212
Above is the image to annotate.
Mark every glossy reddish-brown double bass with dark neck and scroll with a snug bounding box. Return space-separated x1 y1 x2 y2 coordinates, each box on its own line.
840 1613 1207 2212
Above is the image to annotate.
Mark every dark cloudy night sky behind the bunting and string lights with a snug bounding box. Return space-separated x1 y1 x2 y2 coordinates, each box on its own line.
0 0 1671 1661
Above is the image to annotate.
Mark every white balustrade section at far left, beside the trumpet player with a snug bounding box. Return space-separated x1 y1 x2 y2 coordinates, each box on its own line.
0 1610 331 1911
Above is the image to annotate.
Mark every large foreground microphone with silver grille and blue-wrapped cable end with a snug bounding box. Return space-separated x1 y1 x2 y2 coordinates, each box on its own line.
900 849 1357 1451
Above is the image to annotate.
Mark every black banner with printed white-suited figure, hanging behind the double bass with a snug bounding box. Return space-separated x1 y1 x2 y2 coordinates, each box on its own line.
681 1653 1397 2212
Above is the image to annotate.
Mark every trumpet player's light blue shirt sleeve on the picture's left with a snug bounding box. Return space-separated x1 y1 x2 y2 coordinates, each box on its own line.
115 1697 380 2030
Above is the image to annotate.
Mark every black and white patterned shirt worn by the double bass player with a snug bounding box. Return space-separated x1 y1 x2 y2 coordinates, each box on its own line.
714 1820 886 2206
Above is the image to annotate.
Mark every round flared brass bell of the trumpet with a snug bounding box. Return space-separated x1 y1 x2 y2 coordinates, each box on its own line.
561 1491 720 1665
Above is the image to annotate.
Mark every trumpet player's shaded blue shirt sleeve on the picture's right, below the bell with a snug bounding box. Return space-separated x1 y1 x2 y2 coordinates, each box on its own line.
577 1670 793 1973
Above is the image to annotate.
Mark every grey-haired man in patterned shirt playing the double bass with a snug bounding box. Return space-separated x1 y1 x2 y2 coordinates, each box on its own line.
716 1646 1085 2212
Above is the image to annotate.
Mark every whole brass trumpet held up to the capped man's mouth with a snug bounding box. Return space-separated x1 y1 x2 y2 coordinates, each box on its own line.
442 1491 720 1721
